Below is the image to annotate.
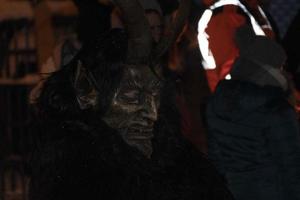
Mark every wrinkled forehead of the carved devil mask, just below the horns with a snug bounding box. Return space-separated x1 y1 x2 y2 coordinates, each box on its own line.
123 65 162 90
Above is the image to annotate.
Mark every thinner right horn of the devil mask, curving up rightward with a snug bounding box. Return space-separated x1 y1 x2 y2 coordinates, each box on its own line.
153 0 191 61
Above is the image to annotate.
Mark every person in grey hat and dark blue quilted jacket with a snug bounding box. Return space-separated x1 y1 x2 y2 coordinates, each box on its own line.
206 27 300 200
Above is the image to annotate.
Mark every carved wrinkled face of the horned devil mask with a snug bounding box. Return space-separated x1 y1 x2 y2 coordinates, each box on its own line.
103 65 162 157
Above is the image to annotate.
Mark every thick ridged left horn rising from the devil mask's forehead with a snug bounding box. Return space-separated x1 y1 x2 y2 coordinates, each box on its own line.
114 0 152 63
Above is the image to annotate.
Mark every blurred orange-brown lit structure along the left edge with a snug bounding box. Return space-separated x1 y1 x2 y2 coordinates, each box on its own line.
0 0 78 200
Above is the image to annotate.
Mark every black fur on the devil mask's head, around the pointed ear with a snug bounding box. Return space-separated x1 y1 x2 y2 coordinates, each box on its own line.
36 29 127 121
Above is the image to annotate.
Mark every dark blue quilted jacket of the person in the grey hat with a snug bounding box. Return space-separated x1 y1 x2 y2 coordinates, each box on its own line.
207 80 300 200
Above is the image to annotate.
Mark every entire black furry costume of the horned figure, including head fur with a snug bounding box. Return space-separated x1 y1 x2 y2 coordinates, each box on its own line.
30 30 232 200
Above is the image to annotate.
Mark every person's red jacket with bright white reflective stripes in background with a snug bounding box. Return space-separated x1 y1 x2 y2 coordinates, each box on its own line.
198 0 274 91
